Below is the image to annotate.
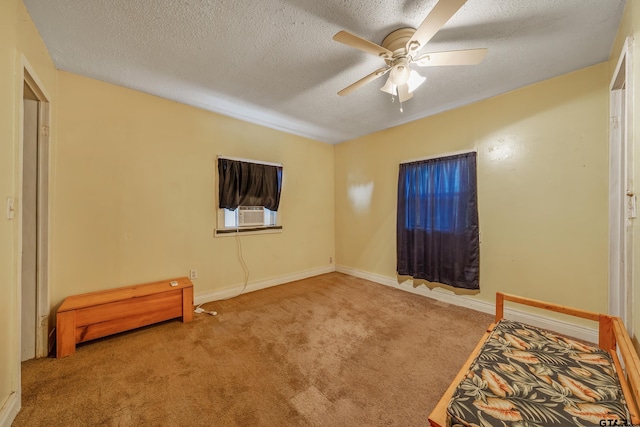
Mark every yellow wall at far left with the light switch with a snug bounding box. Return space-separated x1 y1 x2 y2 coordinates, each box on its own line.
0 0 57 416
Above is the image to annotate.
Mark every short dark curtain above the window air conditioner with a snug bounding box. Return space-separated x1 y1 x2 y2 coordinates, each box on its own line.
218 158 282 211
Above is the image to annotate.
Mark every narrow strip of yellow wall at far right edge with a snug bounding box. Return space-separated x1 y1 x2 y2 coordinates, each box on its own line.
609 1 640 352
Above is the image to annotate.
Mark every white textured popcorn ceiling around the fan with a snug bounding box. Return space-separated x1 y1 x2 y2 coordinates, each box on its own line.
24 0 625 143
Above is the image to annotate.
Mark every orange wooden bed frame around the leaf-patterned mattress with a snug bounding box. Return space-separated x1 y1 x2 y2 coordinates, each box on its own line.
429 292 640 427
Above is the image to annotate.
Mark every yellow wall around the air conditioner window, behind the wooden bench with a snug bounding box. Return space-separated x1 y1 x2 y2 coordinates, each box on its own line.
51 72 334 305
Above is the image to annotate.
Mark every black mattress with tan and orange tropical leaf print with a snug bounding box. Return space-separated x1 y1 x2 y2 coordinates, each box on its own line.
447 319 630 427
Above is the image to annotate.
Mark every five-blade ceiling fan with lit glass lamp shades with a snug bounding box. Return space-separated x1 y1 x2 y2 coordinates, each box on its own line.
333 0 487 111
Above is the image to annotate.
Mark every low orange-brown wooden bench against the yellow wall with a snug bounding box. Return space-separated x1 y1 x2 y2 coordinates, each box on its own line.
56 277 193 357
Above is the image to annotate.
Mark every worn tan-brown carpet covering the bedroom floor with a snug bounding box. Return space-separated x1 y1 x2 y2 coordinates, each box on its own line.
14 273 492 427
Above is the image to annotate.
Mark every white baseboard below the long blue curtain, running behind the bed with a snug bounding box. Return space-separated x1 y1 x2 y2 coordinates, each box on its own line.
336 265 598 343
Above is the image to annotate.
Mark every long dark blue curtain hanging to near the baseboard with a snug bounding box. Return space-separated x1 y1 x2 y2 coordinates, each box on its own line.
397 152 480 289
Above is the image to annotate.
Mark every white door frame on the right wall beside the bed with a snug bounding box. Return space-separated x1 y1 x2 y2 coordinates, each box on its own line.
609 37 636 334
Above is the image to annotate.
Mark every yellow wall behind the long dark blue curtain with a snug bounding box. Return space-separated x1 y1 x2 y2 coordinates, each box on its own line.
335 63 608 318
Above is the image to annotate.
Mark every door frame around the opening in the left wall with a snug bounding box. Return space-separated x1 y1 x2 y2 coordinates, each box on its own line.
16 56 51 366
